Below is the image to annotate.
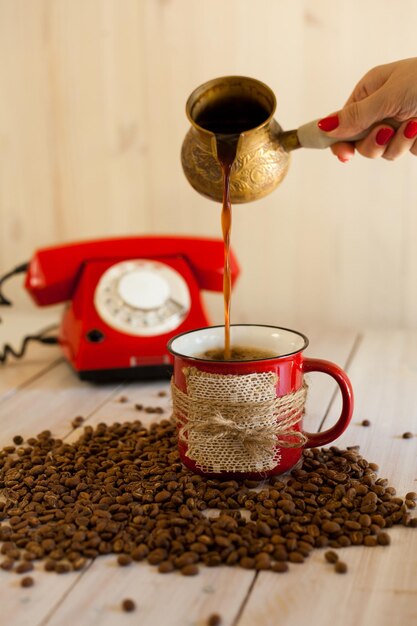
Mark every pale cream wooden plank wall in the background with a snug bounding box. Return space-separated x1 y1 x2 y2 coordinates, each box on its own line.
0 0 417 329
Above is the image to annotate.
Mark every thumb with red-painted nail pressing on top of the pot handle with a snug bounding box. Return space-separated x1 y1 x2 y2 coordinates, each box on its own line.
318 92 390 139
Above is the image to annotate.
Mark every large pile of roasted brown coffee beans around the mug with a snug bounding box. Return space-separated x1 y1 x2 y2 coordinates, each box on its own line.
0 419 417 576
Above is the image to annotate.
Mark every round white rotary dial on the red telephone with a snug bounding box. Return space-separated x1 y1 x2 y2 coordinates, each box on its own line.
94 259 191 337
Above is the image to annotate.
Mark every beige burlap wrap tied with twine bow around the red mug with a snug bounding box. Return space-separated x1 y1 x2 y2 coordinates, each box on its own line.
171 368 307 471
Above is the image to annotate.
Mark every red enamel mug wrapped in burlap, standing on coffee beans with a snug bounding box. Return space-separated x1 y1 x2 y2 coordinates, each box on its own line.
168 324 353 479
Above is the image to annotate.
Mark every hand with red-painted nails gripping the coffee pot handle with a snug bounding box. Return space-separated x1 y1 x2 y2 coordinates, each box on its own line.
318 57 417 162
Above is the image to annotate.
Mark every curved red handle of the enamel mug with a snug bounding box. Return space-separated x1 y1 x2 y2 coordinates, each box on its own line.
303 358 353 448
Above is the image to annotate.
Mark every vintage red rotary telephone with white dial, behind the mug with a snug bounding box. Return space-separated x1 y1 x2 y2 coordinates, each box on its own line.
25 236 239 381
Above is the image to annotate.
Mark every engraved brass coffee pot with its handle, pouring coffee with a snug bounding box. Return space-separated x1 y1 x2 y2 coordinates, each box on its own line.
181 76 398 203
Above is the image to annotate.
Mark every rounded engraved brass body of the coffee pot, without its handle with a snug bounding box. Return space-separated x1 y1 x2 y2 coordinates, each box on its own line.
181 76 289 203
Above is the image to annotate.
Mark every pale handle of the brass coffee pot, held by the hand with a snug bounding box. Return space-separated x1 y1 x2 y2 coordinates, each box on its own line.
279 118 402 152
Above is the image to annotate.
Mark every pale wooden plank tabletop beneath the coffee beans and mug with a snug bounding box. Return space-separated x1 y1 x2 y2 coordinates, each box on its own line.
0 316 417 626
